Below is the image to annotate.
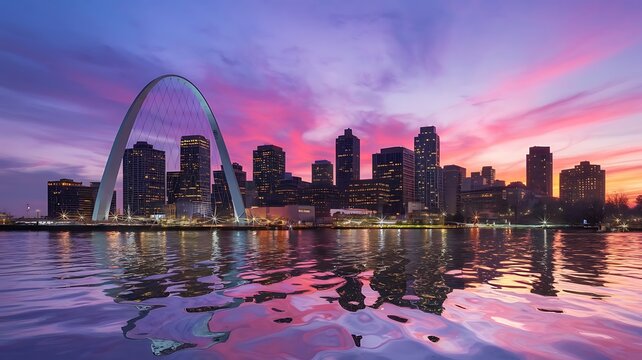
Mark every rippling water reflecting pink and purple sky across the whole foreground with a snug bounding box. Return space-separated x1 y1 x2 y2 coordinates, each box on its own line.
0 229 642 359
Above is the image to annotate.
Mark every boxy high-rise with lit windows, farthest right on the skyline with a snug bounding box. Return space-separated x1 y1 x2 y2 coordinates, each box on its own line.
560 161 606 205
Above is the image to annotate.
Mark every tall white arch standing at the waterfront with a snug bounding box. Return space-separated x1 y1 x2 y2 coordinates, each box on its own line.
92 75 245 221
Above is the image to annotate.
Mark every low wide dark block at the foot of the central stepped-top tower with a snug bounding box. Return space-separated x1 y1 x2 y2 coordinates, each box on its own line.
348 179 390 214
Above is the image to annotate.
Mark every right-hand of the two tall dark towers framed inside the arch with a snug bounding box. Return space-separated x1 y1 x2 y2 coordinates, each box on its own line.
179 135 212 216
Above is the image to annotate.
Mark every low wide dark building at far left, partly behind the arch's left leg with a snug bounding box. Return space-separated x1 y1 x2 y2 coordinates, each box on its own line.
47 179 116 220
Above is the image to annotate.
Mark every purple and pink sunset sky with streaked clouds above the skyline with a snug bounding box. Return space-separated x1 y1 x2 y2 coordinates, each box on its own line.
0 0 642 216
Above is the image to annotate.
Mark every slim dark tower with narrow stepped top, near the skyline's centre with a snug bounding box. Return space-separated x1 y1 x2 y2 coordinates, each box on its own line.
335 129 361 193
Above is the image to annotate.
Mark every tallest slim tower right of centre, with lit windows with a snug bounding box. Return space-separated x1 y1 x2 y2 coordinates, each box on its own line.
415 126 443 212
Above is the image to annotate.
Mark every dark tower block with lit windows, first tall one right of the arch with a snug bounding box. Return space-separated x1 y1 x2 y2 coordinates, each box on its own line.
252 145 285 206
